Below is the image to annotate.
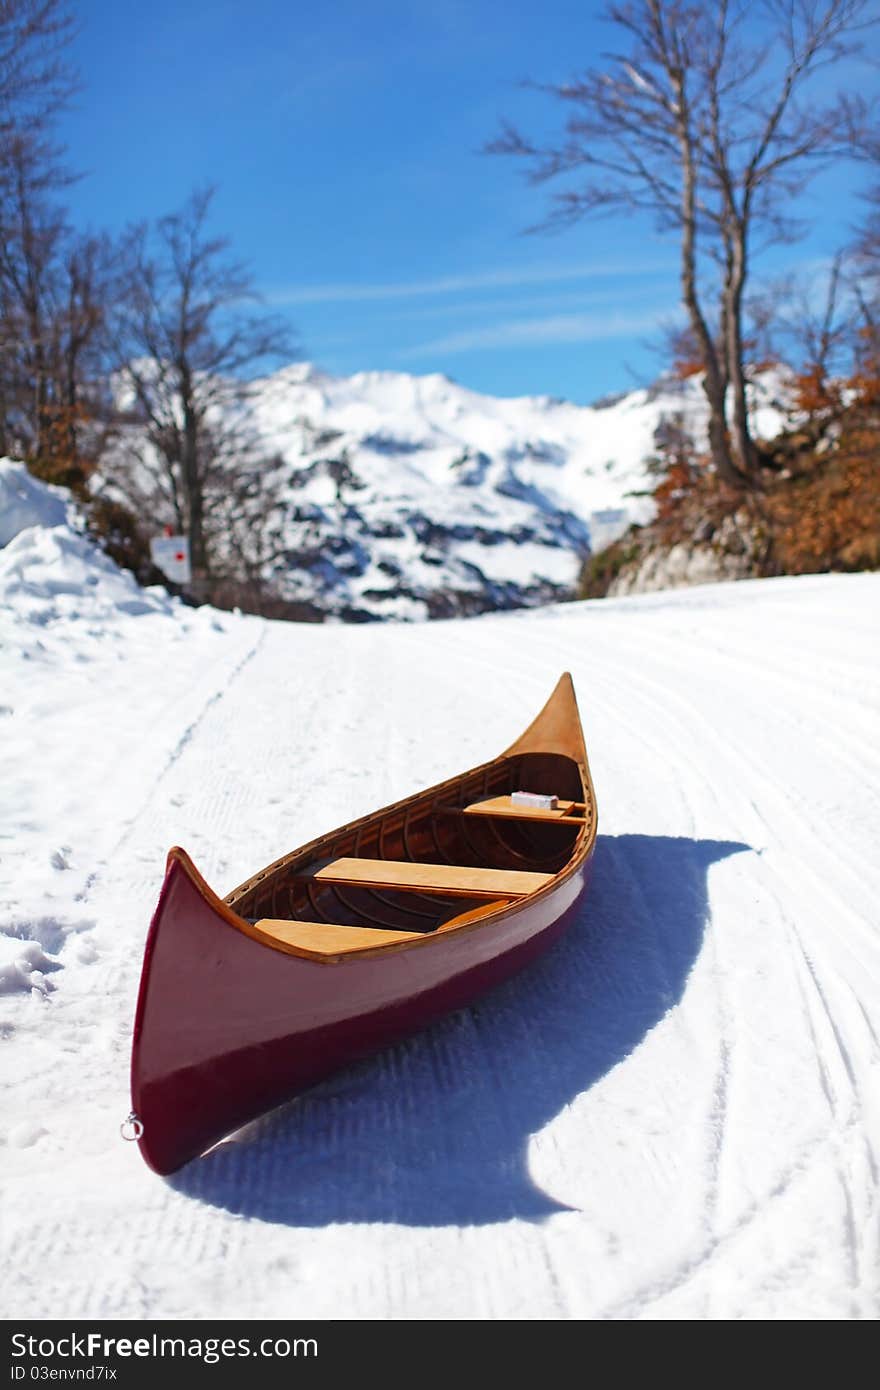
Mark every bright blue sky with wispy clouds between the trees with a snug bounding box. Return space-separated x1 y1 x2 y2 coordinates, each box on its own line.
61 0 873 402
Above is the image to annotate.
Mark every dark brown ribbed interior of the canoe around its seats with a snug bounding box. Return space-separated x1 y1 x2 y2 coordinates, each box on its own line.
225 752 594 933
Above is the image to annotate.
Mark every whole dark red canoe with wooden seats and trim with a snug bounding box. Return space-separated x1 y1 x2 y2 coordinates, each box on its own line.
131 674 596 1173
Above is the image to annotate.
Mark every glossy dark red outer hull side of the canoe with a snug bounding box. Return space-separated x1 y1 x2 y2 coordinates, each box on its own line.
132 852 589 1173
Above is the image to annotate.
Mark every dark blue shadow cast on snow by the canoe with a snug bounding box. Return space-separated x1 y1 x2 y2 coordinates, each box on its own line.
168 835 749 1226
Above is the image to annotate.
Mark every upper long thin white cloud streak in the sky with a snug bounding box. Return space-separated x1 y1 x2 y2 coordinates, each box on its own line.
271 260 671 304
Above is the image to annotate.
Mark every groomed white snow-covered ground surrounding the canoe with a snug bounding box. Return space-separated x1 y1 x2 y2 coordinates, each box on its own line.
0 483 880 1319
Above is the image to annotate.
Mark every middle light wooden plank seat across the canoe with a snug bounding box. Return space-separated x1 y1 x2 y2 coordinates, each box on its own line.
304 859 553 898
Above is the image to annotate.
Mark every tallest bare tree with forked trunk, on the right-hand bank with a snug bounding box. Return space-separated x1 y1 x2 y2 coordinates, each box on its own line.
488 0 867 487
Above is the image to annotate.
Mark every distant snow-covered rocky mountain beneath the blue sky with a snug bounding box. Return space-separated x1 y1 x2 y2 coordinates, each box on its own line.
106 364 780 617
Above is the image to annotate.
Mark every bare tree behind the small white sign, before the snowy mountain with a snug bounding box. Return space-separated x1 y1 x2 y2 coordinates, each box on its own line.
104 188 292 591
